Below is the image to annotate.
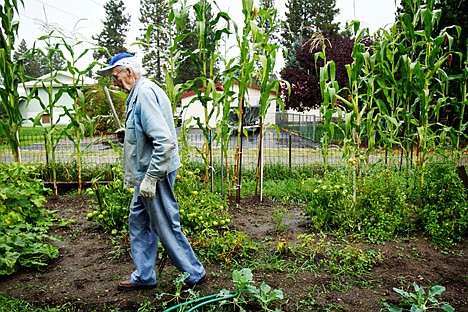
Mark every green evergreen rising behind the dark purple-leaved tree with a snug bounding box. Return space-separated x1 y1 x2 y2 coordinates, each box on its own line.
282 0 340 59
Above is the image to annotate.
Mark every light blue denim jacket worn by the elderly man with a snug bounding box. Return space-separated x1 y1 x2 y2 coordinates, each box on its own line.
124 77 181 188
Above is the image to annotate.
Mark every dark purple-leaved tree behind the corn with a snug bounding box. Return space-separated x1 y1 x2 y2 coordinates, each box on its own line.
281 35 353 112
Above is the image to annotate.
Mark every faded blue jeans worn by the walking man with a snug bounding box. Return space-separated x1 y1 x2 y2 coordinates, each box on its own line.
128 171 206 285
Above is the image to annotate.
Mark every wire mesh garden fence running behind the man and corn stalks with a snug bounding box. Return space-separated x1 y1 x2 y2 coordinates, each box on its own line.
0 129 340 167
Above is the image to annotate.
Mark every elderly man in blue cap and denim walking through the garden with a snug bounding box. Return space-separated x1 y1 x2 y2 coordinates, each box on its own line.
98 53 206 290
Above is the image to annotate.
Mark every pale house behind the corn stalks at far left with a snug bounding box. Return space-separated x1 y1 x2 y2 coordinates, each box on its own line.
18 71 97 126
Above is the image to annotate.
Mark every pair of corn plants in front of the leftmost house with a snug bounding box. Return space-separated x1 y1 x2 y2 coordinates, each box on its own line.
31 29 97 194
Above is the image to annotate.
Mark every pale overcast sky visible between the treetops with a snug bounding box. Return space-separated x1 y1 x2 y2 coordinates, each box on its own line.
18 0 396 69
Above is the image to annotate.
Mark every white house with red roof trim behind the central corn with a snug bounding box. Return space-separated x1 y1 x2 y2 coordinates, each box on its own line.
178 83 278 127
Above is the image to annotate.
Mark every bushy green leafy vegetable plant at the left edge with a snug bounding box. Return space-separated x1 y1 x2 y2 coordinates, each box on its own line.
0 163 59 275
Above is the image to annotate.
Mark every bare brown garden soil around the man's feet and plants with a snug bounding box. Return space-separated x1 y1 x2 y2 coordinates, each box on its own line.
0 195 468 312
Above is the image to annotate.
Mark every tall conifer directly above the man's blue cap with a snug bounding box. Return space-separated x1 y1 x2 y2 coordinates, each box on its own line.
92 0 130 63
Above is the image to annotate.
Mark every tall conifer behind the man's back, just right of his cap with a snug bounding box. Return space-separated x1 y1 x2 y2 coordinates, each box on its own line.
140 0 171 83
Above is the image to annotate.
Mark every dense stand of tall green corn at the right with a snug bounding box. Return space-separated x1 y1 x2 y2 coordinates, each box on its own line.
321 1 463 188
